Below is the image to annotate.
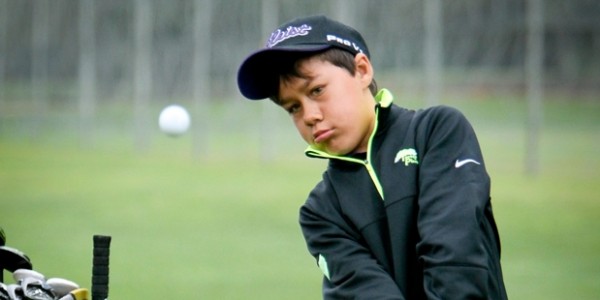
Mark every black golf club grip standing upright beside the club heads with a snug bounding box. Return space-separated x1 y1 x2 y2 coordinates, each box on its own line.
92 235 111 300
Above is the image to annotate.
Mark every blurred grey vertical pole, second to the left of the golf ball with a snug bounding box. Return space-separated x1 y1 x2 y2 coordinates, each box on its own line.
79 0 96 146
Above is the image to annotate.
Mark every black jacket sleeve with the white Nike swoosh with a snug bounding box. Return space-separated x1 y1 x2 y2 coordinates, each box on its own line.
417 107 499 299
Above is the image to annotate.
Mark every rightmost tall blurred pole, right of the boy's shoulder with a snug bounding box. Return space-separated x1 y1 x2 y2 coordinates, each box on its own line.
525 0 544 175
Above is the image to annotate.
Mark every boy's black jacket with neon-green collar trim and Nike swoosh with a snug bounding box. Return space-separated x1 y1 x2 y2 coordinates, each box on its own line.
300 90 507 299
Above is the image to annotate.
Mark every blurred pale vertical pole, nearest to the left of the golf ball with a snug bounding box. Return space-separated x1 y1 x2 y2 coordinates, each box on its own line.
133 0 152 151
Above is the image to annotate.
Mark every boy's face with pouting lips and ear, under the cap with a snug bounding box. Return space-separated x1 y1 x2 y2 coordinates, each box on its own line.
278 54 375 155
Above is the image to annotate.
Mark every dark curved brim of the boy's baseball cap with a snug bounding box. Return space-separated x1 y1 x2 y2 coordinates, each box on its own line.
238 44 331 100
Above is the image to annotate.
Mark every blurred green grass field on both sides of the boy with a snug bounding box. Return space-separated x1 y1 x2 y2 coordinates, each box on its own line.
0 95 600 299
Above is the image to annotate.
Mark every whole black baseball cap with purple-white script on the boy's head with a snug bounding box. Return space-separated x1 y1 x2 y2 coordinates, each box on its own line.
238 16 369 100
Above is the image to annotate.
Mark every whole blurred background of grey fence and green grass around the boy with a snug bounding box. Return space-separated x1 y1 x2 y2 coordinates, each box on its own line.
0 0 600 299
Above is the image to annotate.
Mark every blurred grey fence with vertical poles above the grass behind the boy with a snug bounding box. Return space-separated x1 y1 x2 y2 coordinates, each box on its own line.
0 0 600 164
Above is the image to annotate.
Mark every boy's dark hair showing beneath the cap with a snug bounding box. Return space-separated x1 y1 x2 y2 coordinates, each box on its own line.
269 48 377 103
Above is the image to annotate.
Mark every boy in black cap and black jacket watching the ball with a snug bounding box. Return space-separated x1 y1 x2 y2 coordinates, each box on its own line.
238 16 507 299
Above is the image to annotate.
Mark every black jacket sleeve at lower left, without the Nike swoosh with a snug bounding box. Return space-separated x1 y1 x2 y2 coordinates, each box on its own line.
300 182 404 299
